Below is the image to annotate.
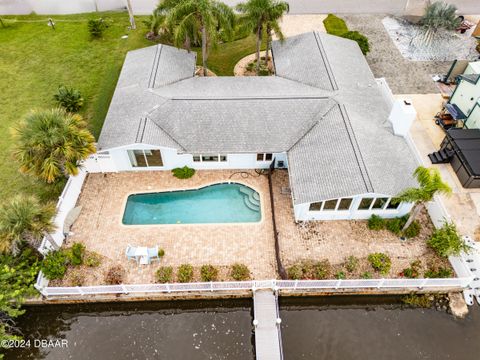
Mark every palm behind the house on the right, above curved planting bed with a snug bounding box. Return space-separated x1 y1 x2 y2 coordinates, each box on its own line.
237 0 289 75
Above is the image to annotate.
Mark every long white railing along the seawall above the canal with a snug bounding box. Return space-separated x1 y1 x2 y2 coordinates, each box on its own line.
37 277 472 297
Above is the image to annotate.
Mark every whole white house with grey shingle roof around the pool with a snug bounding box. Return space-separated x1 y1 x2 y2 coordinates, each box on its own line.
92 33 417 220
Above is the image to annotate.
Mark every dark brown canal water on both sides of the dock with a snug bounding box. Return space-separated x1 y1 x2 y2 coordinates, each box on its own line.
2 297 480 360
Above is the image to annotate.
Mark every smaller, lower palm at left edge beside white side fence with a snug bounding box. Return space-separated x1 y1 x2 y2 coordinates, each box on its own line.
0 195 58 255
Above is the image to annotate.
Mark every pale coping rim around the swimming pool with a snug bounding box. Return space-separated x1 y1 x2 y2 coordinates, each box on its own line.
119 181 265 229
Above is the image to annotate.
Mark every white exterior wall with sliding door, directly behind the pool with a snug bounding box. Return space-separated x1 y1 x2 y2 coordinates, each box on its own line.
84 144 287 172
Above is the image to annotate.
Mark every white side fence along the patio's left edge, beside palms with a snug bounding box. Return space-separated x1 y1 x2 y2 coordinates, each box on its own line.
38 169 87 254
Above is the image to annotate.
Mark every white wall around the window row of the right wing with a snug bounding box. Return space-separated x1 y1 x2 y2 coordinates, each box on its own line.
294 194 413 221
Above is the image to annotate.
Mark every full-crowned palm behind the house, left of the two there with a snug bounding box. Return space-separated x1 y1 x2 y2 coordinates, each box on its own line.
167 0 235 76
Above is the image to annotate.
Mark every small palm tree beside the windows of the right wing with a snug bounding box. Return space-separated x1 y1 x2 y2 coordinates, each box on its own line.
395 166 452 231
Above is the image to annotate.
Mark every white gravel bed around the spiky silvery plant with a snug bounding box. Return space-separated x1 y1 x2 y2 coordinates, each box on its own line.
382 16 479 61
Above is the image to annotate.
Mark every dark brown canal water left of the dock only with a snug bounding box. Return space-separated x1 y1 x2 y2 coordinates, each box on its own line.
6 300 254 360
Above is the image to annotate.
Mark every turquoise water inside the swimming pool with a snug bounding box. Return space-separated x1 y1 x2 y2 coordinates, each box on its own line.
122 183 261 225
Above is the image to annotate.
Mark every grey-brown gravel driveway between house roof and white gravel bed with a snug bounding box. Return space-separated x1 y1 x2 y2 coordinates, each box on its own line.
342 15 451 94
